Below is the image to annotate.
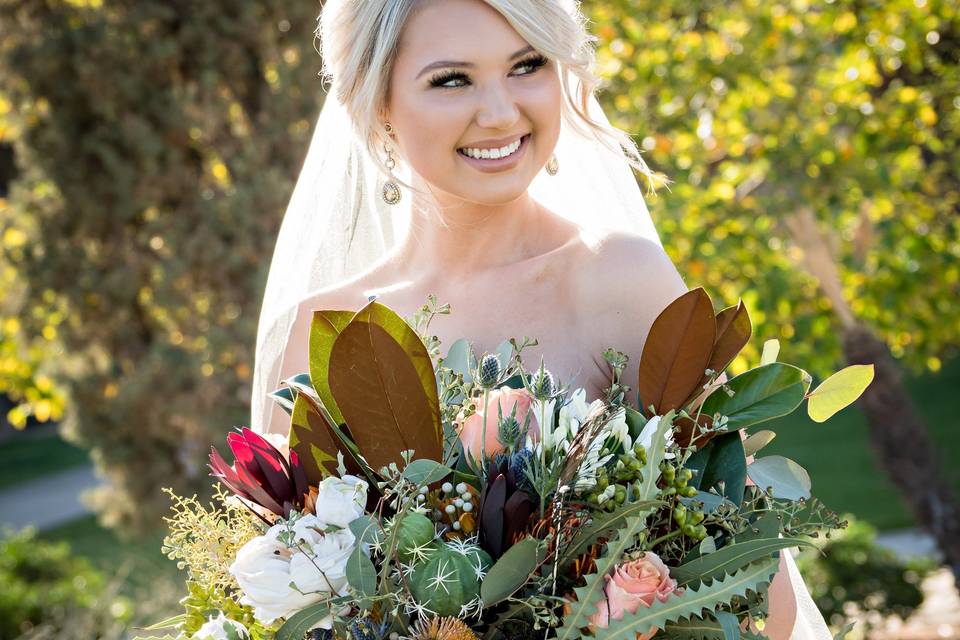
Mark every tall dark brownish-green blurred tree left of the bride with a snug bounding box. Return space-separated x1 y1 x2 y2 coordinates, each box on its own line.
0 0 323 525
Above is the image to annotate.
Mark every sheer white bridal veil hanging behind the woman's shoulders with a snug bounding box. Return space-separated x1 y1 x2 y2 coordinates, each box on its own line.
250 77 831 640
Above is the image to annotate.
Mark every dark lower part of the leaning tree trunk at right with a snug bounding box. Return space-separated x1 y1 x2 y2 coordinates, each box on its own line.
843 325 960 585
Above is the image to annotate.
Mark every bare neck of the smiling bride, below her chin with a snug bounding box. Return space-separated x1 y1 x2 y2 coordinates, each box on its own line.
397 178 550 282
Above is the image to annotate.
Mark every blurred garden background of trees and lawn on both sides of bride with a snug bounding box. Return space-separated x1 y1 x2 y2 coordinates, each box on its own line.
0 0 960 640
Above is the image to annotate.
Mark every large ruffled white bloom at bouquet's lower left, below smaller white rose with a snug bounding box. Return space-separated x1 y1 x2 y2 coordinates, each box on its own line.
230 515 356 629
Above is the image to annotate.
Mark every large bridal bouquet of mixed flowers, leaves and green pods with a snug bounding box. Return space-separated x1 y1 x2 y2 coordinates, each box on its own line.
139 289 873 640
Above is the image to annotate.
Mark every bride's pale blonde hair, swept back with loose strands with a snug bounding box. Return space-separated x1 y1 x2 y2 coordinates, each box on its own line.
316 0 669 192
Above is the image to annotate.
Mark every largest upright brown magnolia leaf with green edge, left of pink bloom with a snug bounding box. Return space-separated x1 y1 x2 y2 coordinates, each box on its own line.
327 302 443 469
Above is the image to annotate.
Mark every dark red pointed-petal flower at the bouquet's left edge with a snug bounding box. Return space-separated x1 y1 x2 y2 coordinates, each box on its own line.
210 427 307 517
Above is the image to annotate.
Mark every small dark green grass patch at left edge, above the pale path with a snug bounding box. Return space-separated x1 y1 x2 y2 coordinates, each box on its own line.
0 432 90 490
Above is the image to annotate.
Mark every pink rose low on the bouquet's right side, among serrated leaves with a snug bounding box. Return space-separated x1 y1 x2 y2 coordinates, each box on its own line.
590 551 683 640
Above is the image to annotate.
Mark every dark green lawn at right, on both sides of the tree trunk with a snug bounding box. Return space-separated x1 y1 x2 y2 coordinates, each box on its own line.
751 358 960 530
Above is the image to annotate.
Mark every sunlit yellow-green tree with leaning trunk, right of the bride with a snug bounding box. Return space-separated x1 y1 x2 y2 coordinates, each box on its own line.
590 0 960 575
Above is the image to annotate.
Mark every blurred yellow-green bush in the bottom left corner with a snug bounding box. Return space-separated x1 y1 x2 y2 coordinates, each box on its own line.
0 530 132 638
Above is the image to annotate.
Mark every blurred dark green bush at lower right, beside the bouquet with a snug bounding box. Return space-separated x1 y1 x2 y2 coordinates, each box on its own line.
797 516 935 623
